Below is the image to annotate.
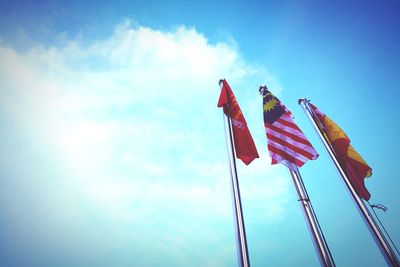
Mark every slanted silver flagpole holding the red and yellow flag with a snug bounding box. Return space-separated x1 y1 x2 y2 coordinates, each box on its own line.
299 99 400 267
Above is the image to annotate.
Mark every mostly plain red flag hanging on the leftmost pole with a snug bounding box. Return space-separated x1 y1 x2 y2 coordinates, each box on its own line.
218 80 259 165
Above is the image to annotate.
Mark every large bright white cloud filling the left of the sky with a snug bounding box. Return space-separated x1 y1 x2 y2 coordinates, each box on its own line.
0 21 288 266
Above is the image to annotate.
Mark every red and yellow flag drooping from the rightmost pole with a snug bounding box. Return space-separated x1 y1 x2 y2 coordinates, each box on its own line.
310 103 372 200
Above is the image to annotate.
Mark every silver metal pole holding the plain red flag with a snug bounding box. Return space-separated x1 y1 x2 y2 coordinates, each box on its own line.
224 111 250 267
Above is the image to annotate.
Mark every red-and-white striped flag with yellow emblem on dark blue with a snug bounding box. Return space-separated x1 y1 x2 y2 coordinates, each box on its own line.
262 88 318 170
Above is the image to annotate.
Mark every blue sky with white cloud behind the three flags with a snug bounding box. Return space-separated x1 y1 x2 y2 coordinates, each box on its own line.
0 0 400 267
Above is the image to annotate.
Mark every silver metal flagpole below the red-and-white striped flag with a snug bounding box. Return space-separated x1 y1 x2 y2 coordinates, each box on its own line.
289 168 336 267
